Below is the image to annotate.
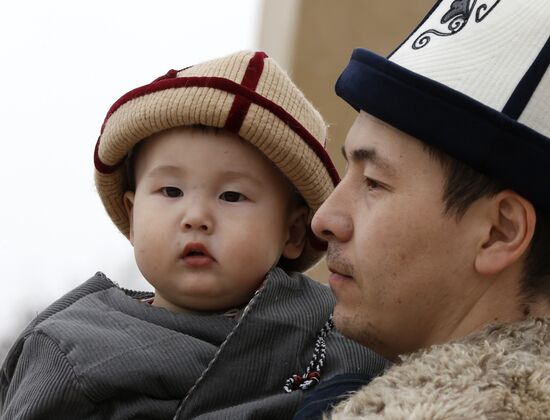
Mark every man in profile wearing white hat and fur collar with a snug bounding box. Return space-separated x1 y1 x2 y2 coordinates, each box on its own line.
306 0 550 419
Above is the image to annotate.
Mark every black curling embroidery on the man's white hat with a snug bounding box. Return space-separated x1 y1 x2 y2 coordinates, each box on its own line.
412 0 500 50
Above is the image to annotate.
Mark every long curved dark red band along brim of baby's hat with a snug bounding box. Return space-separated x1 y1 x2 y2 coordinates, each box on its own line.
94 77 340 185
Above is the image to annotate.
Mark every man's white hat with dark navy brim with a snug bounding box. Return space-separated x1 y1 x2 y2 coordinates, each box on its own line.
336 0 550 211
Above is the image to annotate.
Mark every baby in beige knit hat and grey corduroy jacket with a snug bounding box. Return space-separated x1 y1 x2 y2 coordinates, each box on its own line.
0 51 385 419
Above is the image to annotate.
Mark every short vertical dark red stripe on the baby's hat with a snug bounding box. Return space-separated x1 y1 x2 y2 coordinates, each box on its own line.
224 51 267 134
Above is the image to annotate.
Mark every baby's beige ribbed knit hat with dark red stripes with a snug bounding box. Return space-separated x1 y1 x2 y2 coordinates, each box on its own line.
94 51 339 271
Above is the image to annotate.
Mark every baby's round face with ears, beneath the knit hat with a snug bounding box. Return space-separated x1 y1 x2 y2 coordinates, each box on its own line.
125 128 304 311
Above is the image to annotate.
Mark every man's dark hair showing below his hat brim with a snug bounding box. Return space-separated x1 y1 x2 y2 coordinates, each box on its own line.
423 143 550 299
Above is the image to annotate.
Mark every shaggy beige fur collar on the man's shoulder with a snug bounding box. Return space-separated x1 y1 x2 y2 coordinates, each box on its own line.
329 317 550 420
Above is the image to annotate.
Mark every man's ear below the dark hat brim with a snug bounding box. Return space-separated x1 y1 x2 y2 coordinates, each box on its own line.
475 190 537 275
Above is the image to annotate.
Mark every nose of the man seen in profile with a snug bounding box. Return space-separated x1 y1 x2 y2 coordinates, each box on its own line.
311 183 353 242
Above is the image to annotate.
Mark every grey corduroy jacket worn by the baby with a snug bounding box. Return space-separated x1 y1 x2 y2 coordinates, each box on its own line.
0 269 384 420
